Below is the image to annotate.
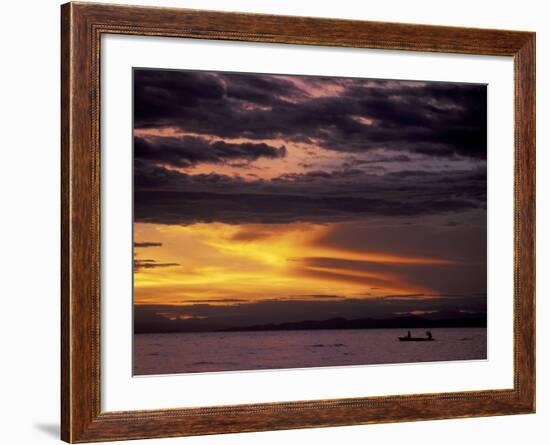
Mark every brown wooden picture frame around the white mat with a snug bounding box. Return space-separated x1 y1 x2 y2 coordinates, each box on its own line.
61 3 535 443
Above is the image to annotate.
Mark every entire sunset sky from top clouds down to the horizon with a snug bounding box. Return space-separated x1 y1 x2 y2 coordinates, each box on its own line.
134 69 487 332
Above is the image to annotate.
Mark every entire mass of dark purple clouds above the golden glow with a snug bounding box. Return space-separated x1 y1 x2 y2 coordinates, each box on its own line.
134 69 487 225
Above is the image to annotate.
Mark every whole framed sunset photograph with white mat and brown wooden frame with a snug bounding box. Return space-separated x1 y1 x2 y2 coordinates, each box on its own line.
61 3 535 443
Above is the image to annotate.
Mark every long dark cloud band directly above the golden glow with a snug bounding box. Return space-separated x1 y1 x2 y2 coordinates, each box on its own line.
135 191 476 224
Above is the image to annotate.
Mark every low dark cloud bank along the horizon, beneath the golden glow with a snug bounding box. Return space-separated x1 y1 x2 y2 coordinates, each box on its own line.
134 294 487 332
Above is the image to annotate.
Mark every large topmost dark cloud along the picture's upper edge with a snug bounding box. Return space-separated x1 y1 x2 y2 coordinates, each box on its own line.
134 70 487 159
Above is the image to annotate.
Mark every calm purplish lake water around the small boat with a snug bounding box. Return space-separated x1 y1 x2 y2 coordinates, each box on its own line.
134 328 487 375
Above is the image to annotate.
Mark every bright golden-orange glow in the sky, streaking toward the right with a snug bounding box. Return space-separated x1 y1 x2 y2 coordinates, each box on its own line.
134 223 451 304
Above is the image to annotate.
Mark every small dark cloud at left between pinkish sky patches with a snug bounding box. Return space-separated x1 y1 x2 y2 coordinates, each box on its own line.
134 136 286 167
